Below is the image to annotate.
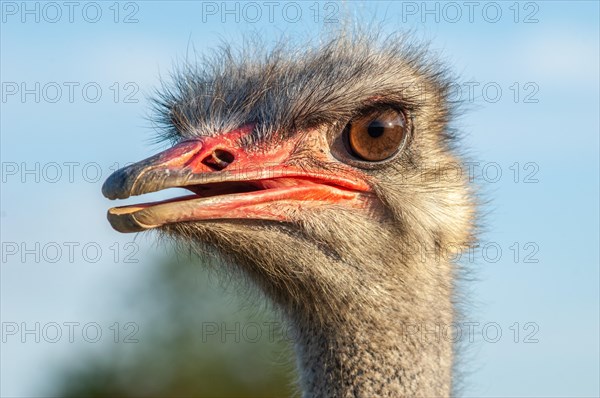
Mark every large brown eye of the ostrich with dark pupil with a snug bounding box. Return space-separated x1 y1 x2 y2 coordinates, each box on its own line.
348 110 406 161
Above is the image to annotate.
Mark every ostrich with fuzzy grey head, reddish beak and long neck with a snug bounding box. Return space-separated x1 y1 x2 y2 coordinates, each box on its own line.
102 32 475 397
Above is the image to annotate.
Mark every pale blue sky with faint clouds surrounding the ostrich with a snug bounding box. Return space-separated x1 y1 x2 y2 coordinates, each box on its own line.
0 1 600 396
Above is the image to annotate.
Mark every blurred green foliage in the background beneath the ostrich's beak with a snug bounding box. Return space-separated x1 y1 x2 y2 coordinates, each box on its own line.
56 256 298 397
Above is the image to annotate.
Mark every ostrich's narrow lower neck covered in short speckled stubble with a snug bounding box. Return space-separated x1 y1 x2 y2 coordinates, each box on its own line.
292 256 453 397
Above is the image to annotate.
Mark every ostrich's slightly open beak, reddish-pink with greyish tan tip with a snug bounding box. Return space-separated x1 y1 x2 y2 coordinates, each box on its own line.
102 126 370 232
